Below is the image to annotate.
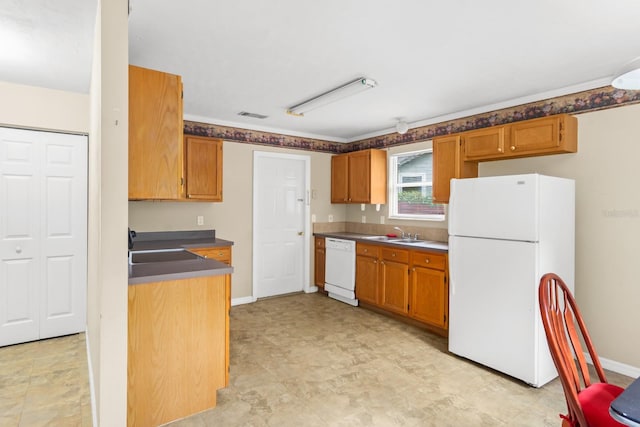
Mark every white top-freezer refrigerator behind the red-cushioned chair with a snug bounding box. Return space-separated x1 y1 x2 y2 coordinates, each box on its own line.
449 174 575 387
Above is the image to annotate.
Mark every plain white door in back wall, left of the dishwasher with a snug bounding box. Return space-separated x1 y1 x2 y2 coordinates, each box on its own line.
253 152 309 298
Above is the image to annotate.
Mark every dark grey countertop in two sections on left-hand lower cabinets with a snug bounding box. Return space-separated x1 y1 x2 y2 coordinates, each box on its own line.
129 230 233 285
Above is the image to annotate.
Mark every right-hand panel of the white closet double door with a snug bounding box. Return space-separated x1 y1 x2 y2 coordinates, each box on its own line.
40 133 87 338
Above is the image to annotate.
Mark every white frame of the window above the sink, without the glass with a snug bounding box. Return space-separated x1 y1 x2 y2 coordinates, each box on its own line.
387 148 446 222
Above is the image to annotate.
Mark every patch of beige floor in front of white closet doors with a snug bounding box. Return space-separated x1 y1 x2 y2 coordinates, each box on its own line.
0 334 92 427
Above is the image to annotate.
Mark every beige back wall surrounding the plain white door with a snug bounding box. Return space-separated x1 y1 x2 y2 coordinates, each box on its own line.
129 141 345 299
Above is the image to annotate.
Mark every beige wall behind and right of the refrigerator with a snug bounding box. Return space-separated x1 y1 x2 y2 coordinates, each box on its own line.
479 105 640 369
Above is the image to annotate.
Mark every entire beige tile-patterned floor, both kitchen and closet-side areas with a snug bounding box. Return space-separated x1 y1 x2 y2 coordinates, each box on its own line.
0 294 632 427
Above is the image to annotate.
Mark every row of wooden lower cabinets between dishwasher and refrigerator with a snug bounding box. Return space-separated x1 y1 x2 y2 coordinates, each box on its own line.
356 243 449 336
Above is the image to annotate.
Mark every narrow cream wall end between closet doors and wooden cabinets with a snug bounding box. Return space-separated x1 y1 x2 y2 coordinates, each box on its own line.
87 0 129 426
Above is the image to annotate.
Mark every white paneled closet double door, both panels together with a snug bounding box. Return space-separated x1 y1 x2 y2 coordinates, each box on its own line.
0 128 87 345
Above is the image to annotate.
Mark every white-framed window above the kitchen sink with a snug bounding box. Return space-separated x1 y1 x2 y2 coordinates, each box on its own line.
389 150 444 221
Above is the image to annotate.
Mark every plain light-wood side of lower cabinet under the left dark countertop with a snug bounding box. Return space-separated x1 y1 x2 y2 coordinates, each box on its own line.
127 275 229 426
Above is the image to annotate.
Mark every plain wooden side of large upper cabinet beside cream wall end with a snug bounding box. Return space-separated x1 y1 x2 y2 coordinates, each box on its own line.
129 65 183 200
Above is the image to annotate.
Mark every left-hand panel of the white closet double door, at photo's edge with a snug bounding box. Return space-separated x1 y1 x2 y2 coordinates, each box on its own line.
0 128 40 345
